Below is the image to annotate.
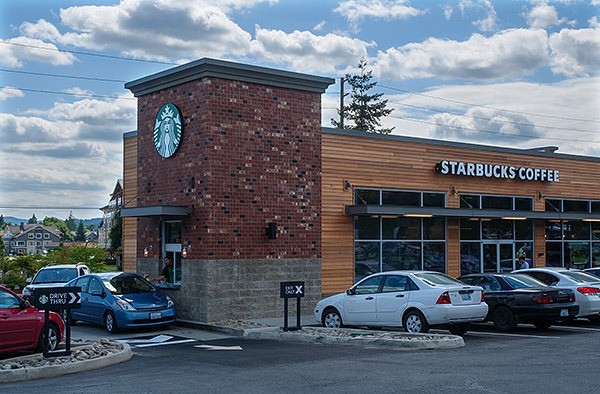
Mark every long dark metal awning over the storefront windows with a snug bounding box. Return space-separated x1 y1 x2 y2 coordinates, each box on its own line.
344 204 600 222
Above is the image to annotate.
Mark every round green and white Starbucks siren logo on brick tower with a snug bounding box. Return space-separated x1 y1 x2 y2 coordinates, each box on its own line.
154 104 181 157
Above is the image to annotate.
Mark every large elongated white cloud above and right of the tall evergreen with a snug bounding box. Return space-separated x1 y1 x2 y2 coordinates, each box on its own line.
373 29 548 80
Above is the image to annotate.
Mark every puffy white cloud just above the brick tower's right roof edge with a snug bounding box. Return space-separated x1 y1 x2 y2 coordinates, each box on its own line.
252 26 375 73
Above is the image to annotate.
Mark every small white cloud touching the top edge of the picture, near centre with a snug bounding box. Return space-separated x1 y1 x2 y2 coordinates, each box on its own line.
333 0 427 30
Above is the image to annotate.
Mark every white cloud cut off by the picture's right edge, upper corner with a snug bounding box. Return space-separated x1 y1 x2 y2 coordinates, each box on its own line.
550 29 600 77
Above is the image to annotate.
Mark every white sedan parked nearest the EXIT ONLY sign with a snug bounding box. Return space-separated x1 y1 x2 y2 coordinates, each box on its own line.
314 271 488 335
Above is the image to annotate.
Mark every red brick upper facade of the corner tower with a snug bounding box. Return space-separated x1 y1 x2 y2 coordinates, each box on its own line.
137 77 321 260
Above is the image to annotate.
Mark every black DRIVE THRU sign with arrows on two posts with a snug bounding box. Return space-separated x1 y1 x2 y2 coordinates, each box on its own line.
33 287 81 357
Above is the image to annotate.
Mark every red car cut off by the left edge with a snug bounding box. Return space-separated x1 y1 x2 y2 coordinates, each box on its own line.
0 286 64 353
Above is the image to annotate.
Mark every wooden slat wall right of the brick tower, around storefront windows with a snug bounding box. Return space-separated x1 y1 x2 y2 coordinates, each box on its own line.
322 132 600 293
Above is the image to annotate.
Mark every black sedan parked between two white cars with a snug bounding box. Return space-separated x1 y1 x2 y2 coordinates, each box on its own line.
458 273 579 331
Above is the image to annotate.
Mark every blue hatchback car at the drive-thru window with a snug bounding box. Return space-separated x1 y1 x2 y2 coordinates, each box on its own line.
65 272 176 334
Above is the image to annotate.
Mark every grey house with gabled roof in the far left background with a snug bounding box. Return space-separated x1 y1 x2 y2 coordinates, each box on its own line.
2 223 63 256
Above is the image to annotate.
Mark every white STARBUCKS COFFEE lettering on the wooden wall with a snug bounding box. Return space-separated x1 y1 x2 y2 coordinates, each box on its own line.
435 160 559 182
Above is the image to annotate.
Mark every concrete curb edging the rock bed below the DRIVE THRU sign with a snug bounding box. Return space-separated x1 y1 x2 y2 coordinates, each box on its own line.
0 343 133 383
